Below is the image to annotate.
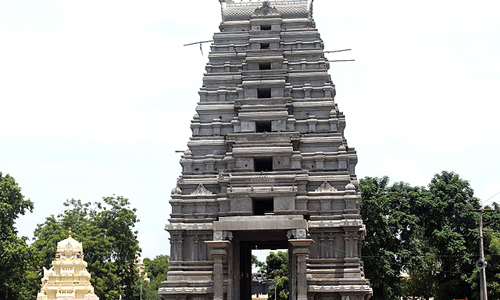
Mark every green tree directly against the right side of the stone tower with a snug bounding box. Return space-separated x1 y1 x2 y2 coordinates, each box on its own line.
360 177 428 300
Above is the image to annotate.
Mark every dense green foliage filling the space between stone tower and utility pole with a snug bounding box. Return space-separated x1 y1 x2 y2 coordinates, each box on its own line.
360 172 494 300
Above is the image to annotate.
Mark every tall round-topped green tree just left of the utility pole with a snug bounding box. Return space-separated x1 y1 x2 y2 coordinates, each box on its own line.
419 171 480 300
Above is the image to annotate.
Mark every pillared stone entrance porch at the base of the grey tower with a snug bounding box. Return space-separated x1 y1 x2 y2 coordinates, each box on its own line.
207 216 313 300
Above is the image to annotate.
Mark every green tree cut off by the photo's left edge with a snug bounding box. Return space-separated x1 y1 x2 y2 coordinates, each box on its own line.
0 172 33 300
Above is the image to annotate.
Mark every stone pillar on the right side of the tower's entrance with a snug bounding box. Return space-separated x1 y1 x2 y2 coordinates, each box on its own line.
289 238 314 300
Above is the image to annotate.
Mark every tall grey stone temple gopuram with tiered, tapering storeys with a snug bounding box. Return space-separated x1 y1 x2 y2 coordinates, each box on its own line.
159 0 372 300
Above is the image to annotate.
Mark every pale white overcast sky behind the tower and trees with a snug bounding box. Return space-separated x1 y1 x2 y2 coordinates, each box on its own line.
0 0 500 257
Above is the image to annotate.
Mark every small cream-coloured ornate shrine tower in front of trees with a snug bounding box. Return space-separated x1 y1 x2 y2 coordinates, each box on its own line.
37 230 99 300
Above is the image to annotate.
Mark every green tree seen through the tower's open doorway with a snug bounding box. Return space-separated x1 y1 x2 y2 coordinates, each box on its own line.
262 251 289 300
